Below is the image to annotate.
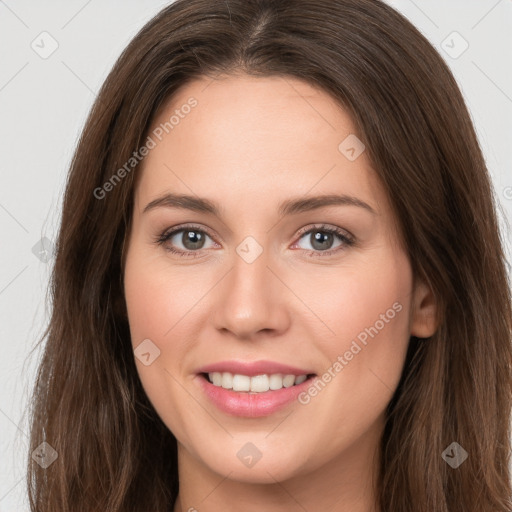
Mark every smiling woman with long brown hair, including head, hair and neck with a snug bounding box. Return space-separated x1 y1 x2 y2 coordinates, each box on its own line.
28 0 512 512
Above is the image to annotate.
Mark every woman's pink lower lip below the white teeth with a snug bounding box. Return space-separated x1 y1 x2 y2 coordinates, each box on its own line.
197 375 314 418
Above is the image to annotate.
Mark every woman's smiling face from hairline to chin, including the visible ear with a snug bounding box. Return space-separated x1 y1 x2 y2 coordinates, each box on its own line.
124 72 429 483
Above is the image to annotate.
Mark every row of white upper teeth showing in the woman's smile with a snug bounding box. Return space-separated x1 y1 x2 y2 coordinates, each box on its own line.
208 372 308 393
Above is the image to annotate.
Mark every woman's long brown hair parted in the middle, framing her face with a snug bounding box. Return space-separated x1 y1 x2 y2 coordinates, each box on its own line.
27 0 512 512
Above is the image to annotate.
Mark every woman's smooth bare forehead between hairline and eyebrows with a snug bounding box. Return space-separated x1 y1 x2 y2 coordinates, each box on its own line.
136 75 384 216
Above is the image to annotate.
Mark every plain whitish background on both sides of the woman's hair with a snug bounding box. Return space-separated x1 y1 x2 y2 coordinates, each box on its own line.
0 0 512 512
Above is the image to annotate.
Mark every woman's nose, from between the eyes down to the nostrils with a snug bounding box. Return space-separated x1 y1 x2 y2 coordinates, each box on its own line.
215 237 289 338
